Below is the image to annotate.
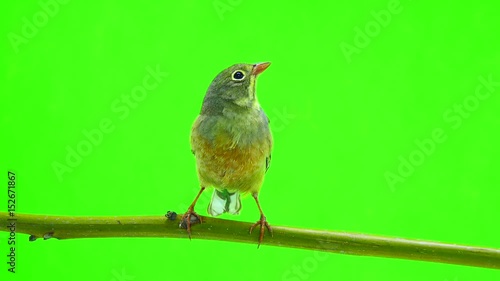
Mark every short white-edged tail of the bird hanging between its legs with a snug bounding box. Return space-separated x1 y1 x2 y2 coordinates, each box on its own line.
208 188 241 217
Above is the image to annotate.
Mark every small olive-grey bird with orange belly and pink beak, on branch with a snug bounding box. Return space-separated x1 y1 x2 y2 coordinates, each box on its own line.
181 62 273 245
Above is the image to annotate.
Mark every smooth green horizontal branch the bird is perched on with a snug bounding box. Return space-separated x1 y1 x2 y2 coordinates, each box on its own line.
0 212 500 269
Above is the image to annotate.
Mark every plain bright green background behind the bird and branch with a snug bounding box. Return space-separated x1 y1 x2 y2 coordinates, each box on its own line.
0 0 500 281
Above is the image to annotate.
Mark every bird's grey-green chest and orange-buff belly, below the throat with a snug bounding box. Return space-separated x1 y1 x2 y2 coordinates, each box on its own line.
191 115 272 193
